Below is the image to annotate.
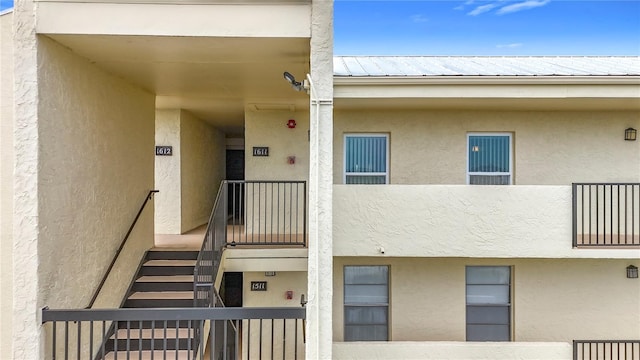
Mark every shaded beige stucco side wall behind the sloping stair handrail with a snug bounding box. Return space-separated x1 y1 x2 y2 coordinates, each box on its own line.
34 37 154 358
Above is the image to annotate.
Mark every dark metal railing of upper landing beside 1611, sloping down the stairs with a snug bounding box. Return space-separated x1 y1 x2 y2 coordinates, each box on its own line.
193 180 307 307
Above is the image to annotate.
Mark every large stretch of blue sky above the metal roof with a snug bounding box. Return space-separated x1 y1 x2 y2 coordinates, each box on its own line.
334 0 640 55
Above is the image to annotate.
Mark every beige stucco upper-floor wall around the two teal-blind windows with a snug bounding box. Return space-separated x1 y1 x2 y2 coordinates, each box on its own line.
333 110 640 185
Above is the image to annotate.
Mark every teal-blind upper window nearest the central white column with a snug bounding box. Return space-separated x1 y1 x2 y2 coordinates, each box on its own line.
344 134 389 184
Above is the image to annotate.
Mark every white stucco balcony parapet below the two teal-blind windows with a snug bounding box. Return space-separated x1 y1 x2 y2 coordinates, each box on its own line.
333 185 640 259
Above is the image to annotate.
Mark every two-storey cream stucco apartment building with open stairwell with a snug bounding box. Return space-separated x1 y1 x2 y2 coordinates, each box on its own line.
0 0 640 359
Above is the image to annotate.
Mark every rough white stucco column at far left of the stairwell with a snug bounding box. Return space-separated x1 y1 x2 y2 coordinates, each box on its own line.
11 0 44 359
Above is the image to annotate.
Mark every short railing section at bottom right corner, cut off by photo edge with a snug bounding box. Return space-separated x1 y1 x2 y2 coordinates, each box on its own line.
573 340 640 360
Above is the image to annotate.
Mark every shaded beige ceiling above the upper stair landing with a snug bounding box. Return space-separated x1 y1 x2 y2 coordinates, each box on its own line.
45 35 310 134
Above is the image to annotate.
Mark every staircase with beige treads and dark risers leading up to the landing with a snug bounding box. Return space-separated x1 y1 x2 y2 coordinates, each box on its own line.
104 249 198 360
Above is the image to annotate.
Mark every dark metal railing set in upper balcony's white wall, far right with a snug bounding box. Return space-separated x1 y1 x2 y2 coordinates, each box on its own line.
573 183 640 247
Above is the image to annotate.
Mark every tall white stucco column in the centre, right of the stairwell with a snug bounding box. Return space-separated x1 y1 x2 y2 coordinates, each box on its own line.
306 0 333 360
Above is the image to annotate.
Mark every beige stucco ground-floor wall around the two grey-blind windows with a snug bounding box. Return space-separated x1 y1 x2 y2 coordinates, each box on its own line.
333 257 640 342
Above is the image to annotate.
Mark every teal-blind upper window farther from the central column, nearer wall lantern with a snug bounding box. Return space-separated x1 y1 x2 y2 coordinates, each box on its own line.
467 133 513 185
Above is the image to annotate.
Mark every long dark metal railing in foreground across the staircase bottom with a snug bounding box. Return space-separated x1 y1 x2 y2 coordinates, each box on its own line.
42 307 305 360
